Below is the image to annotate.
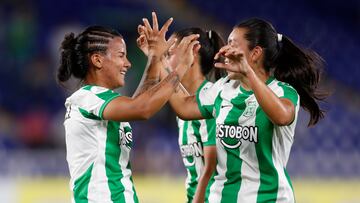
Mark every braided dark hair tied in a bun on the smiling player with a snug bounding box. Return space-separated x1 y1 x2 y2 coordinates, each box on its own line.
57 26 122 83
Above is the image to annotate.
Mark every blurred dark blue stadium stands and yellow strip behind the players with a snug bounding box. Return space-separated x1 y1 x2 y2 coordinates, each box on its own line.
0 0 360 203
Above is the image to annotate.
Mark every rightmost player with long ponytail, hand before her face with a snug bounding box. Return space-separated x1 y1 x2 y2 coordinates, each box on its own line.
166 19 324 203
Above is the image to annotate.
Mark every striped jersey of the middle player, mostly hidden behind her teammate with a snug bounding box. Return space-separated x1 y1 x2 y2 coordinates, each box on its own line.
177 80 215 203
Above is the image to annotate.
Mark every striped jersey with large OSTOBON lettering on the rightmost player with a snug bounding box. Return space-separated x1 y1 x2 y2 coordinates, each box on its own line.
198 77 300 203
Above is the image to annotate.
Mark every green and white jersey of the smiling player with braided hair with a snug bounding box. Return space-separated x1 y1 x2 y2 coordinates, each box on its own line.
64 85 138 203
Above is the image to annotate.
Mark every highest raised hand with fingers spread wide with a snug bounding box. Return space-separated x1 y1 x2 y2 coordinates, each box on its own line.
137 12 176 58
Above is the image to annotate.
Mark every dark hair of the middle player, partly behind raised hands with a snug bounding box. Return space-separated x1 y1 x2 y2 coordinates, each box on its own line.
174 27 225 80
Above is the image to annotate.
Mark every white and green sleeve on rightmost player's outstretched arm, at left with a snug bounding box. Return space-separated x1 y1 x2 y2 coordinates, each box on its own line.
196 79 222 119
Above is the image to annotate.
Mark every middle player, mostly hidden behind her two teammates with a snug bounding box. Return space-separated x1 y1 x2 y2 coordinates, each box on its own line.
137 26 224 203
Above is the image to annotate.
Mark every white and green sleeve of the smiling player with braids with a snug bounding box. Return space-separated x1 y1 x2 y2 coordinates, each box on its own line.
78 86 121 120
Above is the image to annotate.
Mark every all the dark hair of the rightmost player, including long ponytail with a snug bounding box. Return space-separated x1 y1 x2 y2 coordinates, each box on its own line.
235 18 326 126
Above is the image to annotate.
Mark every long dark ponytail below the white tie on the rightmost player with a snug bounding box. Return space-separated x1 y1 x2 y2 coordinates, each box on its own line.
274 36 326 126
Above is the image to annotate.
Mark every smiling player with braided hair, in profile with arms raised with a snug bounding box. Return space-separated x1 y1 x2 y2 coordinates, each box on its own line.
57 13 199 203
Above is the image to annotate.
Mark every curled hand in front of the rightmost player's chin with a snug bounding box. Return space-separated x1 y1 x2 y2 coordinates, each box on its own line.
214 45 251 76
